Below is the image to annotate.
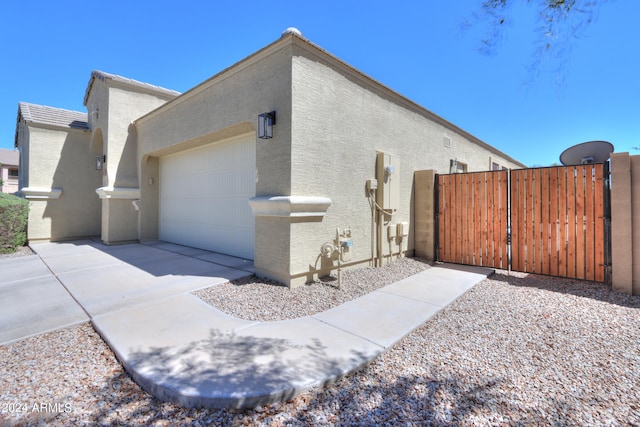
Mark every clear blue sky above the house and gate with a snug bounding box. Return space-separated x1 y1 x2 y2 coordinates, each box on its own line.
0 0 640 166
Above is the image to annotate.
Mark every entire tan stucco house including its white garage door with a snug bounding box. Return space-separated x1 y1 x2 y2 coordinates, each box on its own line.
16 31 524 286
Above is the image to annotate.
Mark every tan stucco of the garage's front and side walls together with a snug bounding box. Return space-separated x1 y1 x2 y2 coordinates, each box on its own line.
135 36 522 285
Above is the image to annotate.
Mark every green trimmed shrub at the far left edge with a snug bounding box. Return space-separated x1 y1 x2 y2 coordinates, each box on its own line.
0 193 29 253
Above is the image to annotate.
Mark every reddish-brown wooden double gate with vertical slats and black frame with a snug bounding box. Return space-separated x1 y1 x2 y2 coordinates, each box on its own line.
436 164 608 282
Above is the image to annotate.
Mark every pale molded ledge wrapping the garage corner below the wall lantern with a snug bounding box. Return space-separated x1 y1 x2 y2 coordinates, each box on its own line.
249 196 331 217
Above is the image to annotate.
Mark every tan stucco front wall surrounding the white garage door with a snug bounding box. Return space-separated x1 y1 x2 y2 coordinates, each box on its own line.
136 43 291 282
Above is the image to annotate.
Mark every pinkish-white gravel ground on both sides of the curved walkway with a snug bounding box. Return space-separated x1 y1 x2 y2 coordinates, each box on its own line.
0 260 640 426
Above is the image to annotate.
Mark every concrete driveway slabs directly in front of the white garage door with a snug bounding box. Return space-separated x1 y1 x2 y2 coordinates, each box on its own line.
0 240 254 345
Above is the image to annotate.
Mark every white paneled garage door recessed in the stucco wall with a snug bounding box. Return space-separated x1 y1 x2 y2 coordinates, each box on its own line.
159 134 256 259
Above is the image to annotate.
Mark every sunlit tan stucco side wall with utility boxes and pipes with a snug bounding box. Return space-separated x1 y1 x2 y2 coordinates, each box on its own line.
290 44 522 286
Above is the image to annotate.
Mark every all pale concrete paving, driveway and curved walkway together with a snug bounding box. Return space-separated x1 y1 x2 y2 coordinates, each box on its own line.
0 241 492 407
